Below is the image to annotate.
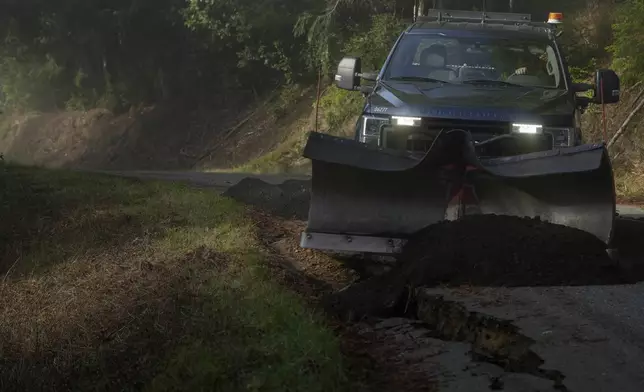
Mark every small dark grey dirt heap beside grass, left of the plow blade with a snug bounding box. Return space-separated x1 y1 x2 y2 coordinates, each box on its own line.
223 177 311 220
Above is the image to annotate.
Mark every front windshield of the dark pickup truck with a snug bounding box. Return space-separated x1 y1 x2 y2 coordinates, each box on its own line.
383 34 565 89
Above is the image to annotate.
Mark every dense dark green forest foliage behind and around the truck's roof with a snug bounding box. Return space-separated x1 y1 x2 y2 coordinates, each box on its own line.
0 0 644 115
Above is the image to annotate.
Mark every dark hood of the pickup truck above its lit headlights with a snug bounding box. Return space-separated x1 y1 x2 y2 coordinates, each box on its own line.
365 82 575 125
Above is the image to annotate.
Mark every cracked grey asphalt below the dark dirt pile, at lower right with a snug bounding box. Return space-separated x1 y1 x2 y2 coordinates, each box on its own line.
410 284 644 391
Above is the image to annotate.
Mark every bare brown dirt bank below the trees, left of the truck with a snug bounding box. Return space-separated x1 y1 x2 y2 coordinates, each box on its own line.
0 86 350 170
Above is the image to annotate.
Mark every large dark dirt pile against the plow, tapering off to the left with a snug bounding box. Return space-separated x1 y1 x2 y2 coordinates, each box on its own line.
326 215 626 318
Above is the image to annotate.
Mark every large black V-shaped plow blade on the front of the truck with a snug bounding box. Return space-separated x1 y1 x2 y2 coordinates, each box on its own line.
301 132 616 254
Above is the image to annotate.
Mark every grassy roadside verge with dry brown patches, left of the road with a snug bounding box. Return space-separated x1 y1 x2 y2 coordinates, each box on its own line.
0 165 346 392
